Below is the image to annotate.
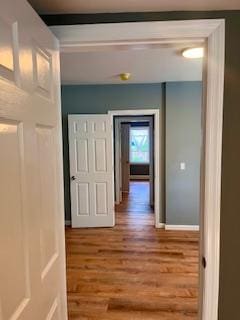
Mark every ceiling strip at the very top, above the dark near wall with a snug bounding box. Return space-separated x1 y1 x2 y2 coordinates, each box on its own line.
29 0 240 13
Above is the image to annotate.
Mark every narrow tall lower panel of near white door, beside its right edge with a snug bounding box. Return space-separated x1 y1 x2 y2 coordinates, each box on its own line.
36 126 58 279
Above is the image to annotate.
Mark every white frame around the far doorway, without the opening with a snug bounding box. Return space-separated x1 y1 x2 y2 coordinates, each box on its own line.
108 109 160 228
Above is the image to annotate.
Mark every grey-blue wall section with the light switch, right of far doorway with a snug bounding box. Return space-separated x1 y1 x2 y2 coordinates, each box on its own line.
166 82 202 225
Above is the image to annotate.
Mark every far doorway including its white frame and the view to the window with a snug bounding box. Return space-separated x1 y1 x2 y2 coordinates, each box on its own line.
108 109 160 228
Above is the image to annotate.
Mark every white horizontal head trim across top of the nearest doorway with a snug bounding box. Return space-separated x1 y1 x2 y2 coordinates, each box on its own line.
50 19 218 52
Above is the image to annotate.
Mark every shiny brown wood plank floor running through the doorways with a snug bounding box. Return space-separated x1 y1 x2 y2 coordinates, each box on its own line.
66 182 198 320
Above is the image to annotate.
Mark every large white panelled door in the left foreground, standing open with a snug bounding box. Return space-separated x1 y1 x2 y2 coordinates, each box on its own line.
0 0 67 320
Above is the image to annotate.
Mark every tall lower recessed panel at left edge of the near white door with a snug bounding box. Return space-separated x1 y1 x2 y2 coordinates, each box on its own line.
0 120 30 319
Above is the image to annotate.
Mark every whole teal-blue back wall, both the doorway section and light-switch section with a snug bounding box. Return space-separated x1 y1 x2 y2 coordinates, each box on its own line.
62 82 201 225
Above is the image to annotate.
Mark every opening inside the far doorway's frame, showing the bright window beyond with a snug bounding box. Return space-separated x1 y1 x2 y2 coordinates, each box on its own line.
113 115 155 224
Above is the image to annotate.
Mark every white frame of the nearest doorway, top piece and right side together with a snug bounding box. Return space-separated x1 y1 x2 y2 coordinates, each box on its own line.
51 19 225 320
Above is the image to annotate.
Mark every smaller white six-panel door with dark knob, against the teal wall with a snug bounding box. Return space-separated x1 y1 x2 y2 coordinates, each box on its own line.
68 115 115 228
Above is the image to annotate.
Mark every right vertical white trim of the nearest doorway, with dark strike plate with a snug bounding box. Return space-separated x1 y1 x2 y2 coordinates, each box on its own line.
200 20 225 320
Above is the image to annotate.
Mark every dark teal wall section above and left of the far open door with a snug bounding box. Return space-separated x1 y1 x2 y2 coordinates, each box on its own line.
62 84 163 220
